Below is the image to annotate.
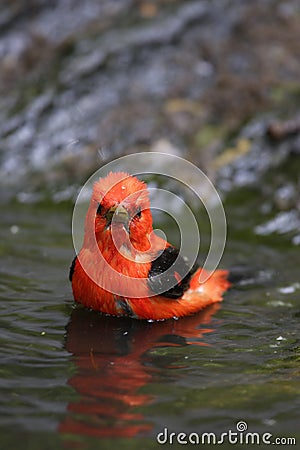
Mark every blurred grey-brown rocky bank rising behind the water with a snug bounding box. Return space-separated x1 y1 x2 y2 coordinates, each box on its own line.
0 0 300 201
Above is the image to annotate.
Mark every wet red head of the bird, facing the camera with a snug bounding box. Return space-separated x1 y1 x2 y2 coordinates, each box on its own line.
86 172 152 251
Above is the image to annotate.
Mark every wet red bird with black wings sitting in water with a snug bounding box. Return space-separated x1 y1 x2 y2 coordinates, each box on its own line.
70 172 230 320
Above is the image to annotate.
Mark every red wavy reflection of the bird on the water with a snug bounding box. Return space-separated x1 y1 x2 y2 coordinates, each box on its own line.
60 304 219 445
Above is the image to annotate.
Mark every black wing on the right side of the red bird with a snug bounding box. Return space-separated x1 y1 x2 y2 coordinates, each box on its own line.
148 247 197 298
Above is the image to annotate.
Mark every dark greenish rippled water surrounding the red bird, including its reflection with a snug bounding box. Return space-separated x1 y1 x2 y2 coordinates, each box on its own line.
0 171 300 449
